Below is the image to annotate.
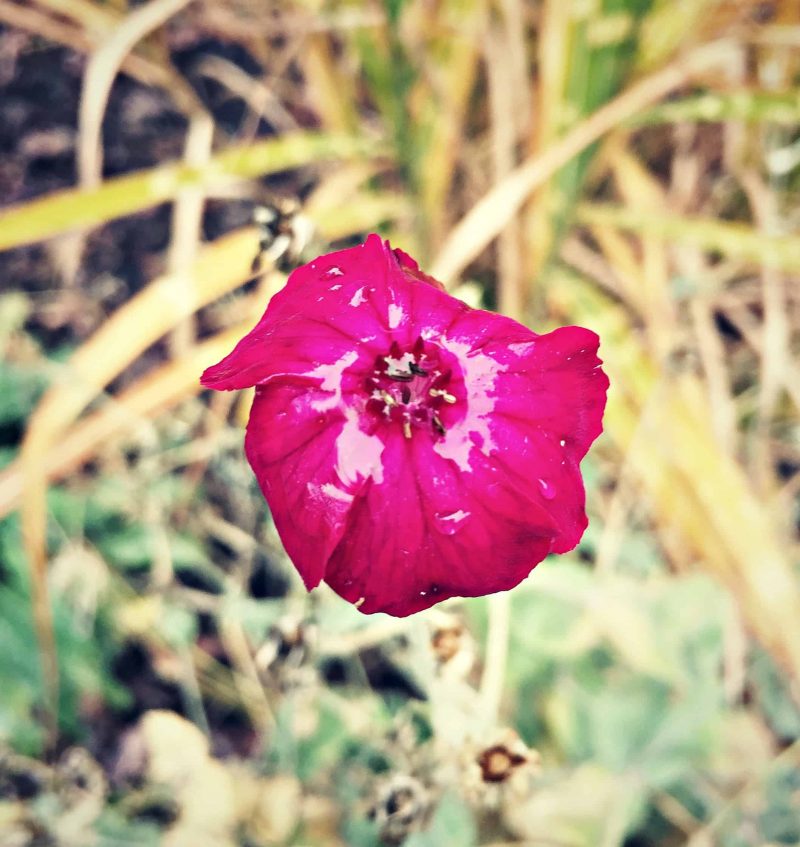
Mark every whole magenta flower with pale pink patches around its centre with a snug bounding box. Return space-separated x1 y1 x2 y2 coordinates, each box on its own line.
202 235 608 616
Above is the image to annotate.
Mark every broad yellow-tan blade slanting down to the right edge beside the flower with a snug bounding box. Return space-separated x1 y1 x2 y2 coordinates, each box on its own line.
558 276 800 680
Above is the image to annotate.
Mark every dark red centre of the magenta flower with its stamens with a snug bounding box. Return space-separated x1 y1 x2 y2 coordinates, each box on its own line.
365 338 458 438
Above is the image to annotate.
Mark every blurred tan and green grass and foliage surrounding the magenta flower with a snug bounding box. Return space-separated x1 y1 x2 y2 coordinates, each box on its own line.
0 0 800 847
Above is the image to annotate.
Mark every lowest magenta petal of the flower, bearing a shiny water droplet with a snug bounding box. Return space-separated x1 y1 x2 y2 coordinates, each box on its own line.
325 433 557 616
